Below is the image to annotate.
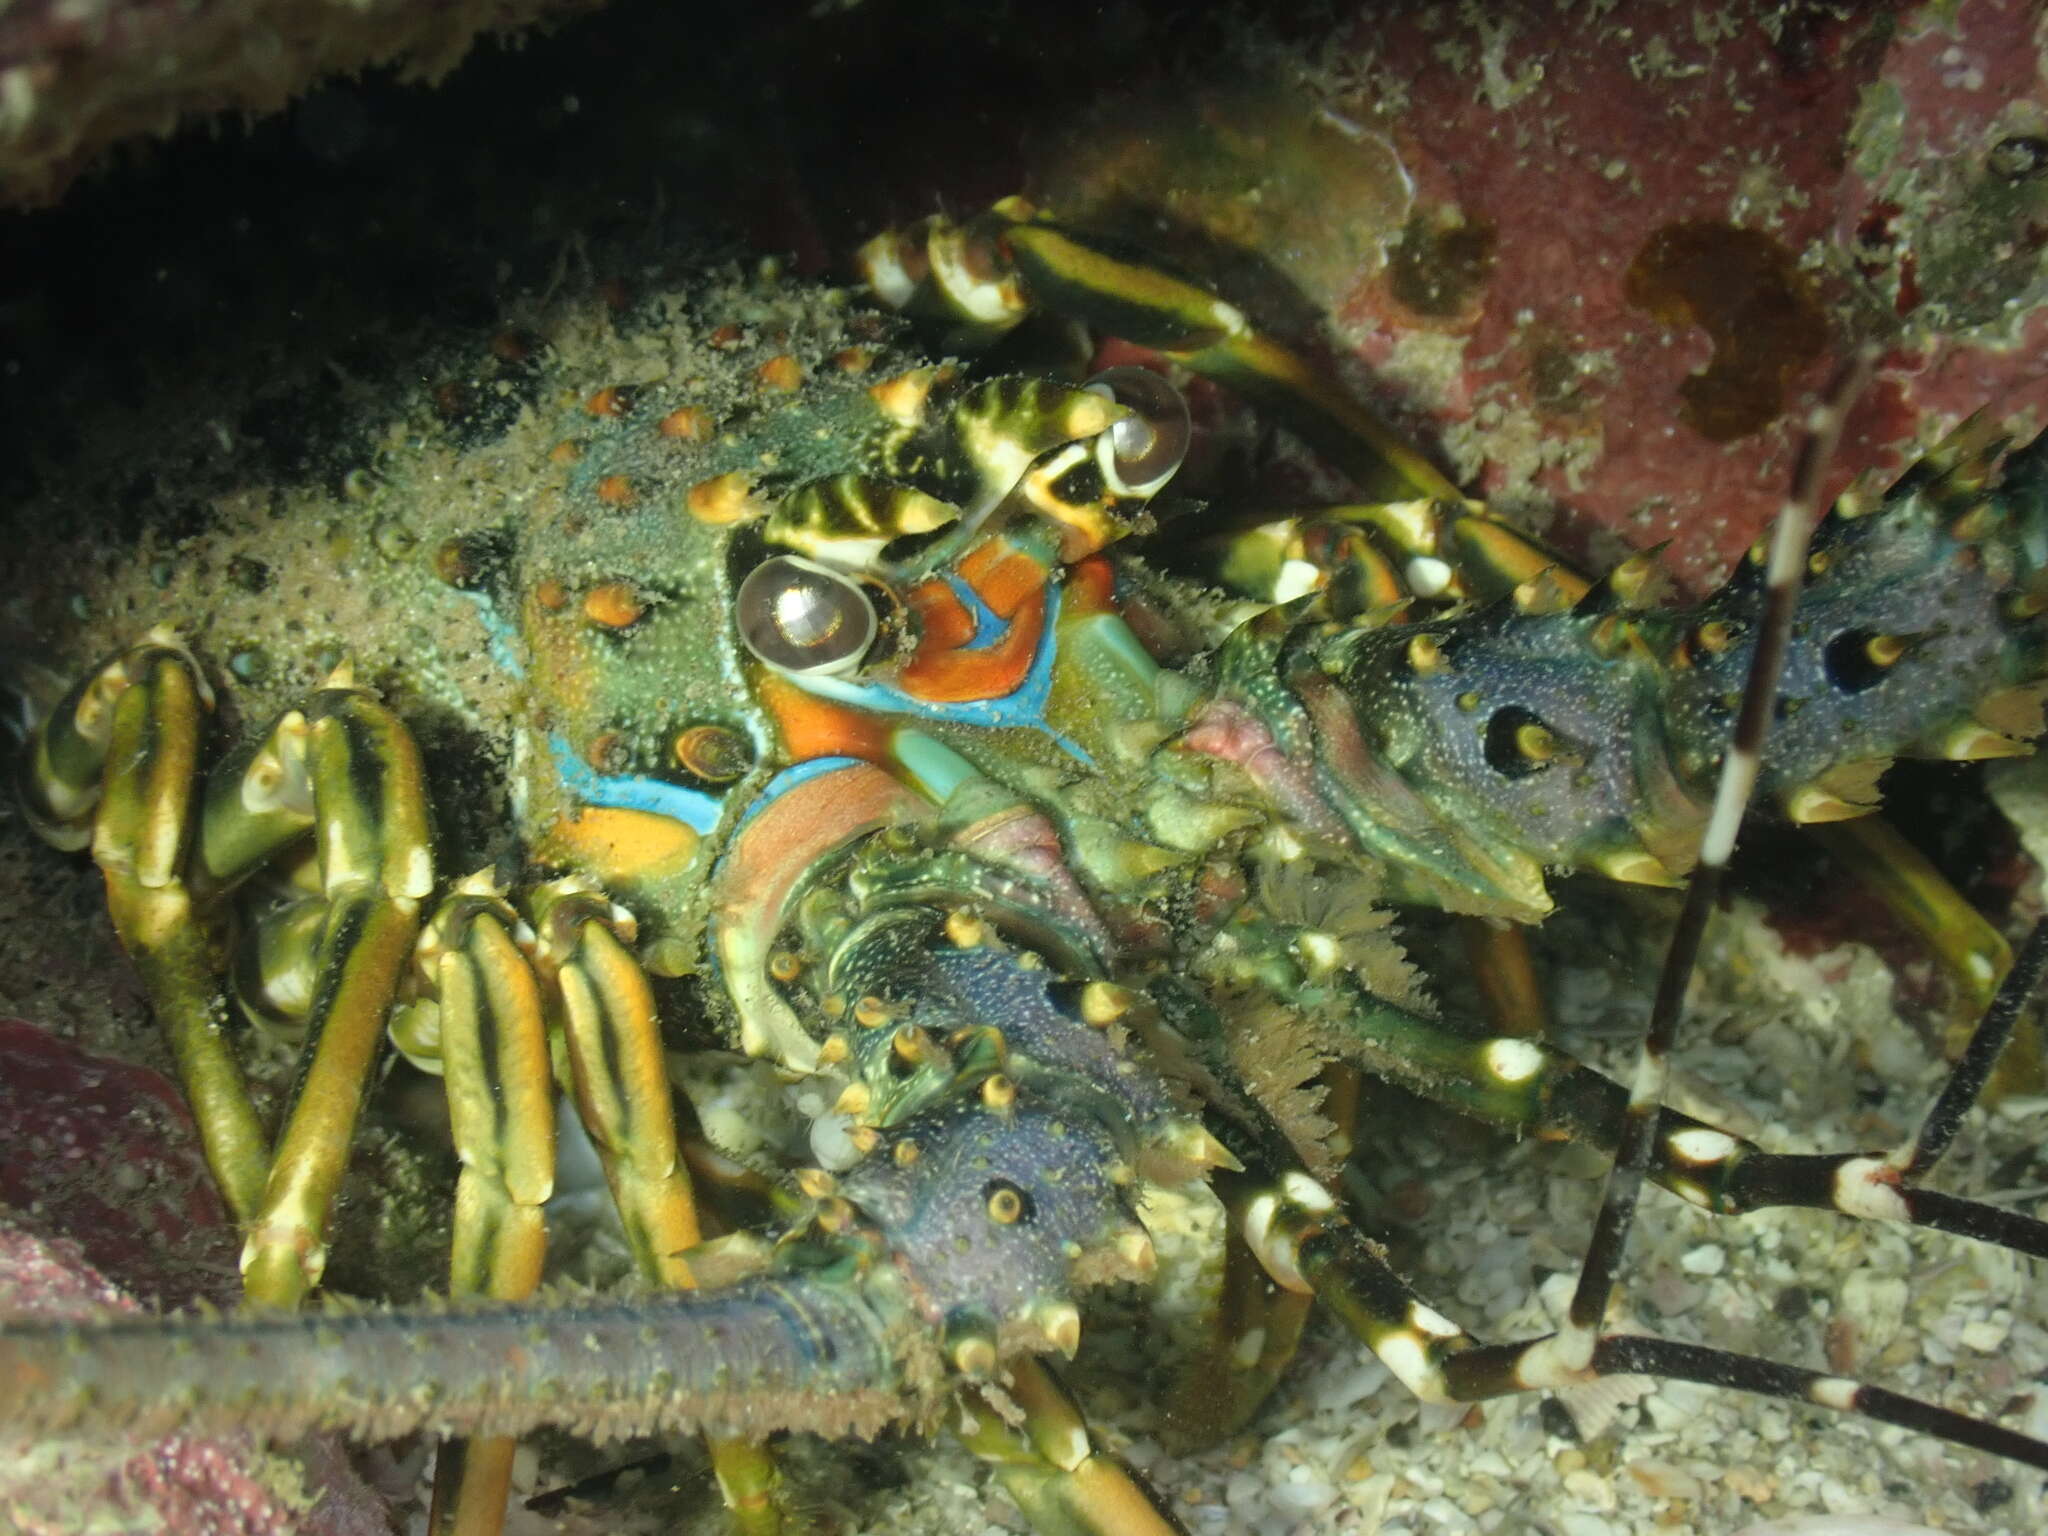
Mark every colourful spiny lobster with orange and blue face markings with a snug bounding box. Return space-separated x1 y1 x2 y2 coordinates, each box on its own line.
0 201 2048 1536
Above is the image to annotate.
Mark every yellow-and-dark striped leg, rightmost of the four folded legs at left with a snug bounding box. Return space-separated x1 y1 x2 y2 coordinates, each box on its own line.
530 879 784 1536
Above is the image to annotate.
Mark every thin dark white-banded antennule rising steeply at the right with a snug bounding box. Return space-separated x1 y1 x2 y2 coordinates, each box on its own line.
1556 346 1876 1366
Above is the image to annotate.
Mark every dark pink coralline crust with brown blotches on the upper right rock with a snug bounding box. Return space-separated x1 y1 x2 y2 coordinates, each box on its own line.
1337 0 2048 586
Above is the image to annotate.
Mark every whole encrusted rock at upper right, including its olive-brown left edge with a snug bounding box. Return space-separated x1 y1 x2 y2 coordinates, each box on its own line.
1003 0 2048 590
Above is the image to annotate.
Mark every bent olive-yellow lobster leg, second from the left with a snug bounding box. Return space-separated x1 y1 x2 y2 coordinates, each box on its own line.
232 674 434 1307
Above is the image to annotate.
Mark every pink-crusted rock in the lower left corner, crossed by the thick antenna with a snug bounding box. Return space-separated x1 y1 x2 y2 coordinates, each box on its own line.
0 1020 391 1536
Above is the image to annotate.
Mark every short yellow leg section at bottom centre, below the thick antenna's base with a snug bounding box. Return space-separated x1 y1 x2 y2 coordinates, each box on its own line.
961 1356 1186 1536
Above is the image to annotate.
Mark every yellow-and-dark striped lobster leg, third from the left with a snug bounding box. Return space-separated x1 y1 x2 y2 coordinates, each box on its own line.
391 872 555 1536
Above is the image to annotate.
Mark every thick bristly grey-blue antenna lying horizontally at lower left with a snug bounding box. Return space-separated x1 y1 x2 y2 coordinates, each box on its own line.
0 1276 944 1440
